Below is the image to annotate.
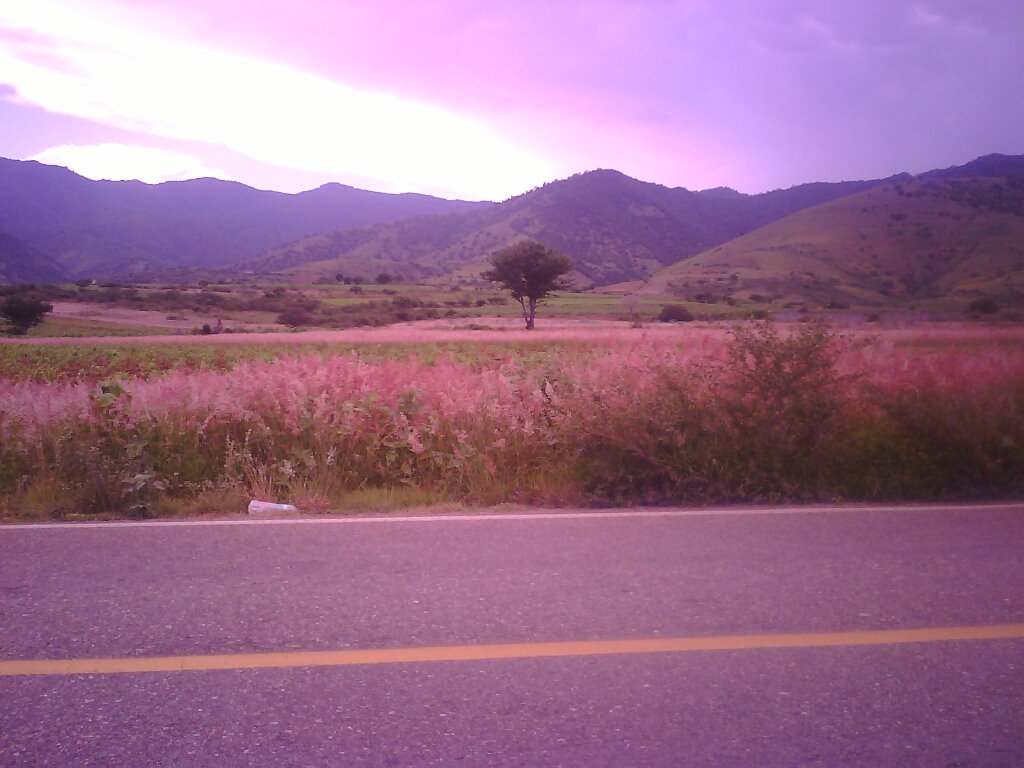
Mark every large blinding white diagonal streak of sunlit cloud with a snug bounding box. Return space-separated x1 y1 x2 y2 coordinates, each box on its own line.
0 0 552 199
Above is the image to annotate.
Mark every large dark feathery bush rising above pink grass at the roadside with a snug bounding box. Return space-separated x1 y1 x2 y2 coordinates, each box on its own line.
581 323 847 503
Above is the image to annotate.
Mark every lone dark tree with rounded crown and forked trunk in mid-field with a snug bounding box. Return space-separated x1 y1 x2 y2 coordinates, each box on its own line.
483 240 572 331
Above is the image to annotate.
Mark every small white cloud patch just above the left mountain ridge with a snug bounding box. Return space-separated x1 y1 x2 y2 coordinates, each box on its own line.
28 143 230 184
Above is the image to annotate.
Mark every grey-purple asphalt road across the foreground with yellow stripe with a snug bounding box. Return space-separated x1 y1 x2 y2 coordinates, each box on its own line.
0 504 1024 768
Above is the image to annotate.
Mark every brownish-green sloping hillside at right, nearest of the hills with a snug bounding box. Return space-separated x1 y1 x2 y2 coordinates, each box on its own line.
641 174 1024 307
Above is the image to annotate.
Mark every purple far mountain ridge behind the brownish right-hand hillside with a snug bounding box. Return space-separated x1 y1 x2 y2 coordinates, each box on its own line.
0 155 1024 294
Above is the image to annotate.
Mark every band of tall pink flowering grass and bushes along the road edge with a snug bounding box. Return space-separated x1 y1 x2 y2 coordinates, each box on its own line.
0 324 1024 515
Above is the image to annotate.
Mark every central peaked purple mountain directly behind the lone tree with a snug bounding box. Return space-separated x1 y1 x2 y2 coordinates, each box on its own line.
249 170 897 286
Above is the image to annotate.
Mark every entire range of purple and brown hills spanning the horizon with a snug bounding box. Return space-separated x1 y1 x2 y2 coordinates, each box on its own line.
0 155 1024 305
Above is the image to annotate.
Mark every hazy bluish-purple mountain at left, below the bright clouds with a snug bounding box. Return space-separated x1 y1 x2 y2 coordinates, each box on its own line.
0 158 489 279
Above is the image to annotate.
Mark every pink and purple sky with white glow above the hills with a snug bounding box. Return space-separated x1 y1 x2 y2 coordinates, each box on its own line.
0 0 1024 200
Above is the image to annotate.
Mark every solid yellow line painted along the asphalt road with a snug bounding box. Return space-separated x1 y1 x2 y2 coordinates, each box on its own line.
0 624 1024 677
